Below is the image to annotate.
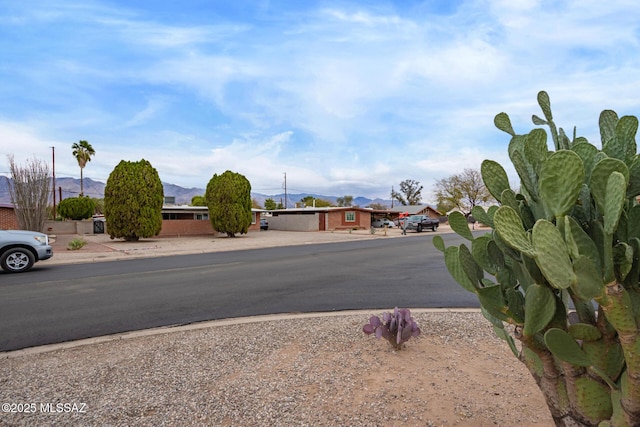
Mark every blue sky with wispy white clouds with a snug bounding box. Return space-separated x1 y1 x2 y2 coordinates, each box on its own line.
0 0 640 202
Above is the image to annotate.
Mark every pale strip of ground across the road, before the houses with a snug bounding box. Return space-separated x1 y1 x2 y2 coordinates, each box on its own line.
47 225 451 264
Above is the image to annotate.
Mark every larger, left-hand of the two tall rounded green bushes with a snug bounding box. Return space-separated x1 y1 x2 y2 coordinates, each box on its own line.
104 159 164 240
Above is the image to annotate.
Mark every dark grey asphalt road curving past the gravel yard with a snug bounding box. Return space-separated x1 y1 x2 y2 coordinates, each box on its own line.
0 233 479 351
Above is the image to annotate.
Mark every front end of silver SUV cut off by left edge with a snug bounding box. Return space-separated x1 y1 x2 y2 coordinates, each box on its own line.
0 230 53 273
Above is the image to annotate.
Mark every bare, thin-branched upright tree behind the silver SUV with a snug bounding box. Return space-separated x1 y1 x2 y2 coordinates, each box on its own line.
8 155 50 232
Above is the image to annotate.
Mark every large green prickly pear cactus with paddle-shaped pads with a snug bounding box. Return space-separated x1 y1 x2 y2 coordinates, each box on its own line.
434 92 640 426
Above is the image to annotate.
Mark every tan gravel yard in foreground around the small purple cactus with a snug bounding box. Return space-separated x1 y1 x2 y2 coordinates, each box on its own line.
0 311 553 427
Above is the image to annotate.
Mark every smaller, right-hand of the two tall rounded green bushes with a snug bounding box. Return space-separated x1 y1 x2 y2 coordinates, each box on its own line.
204 171 251 237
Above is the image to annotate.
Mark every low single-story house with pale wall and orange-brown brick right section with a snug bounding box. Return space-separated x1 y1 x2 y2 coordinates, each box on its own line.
268 207 373 231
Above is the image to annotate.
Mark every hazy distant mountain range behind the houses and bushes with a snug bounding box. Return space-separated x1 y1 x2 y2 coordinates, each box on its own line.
0 176 391 208
